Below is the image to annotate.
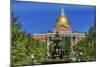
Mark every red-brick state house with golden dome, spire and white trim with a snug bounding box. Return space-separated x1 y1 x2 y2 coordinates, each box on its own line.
33 8 85 55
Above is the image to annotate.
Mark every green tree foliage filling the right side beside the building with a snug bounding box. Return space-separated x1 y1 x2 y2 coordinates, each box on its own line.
74 25 96 61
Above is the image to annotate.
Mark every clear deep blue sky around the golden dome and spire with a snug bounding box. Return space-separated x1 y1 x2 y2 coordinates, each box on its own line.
11 1 96 34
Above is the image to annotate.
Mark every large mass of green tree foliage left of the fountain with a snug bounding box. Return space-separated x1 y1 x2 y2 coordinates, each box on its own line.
11 16 46 66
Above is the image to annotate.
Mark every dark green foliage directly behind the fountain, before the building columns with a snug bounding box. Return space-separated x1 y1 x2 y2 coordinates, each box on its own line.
49 37 71 59
